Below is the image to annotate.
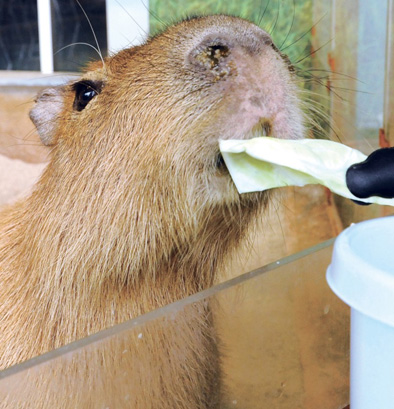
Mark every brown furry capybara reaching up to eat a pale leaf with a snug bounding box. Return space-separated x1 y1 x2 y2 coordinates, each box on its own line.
0 16 303 409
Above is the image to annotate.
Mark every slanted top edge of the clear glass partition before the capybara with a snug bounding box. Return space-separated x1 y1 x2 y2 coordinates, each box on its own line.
0 238 335 381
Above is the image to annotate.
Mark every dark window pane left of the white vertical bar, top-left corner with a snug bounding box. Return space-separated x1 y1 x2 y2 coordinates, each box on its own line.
0 0 40 70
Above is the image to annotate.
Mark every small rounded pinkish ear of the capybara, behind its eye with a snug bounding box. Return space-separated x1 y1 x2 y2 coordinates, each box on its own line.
30 87 64 146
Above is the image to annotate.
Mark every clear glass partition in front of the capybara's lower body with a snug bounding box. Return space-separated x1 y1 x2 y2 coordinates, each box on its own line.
0 242 349 409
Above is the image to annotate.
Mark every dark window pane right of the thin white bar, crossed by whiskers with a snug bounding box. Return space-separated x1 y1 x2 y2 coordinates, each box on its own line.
51 0 107 71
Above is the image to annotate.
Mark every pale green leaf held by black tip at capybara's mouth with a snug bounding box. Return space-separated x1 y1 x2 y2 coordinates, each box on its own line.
219 137 394 206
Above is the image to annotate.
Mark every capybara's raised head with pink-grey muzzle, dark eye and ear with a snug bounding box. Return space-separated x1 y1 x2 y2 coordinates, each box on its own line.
27 16 303 290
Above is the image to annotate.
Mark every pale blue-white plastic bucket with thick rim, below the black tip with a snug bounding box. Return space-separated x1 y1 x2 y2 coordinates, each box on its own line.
327 216 394 409
